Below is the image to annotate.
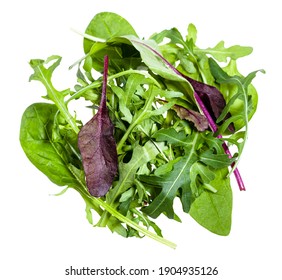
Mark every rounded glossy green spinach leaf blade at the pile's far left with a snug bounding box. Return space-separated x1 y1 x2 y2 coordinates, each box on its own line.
20 103 78 186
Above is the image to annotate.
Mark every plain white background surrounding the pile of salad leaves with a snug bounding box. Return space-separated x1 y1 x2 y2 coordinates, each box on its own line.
0 0 282 280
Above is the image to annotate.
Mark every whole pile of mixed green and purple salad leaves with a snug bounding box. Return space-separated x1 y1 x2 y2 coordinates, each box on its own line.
20 12 263 248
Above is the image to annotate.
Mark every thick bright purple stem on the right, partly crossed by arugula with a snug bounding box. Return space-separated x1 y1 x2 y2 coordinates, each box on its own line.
194 92 246 191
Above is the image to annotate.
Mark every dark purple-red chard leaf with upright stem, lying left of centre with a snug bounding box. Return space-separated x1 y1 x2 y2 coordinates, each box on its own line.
78 56 118 197
